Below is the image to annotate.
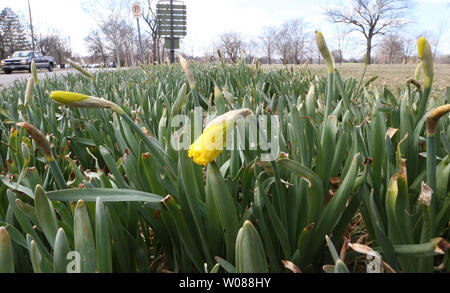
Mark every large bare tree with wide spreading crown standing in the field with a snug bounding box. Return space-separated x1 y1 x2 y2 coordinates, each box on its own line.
325 0 411 64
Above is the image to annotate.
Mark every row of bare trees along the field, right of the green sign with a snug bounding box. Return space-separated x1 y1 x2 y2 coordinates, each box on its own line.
213 0 450 64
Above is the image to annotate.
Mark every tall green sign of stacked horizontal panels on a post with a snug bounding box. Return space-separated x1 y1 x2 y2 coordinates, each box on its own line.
156 0 187 63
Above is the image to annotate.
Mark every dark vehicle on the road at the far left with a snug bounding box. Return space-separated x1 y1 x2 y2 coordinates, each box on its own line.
2 51 55 74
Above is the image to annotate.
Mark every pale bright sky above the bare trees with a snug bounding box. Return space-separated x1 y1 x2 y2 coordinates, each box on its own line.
0 0 450 57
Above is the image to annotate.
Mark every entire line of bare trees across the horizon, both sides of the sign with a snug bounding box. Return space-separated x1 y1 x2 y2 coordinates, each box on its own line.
0 0 450 67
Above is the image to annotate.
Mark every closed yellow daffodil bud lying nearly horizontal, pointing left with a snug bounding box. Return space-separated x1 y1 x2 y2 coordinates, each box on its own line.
50 91 125 115
